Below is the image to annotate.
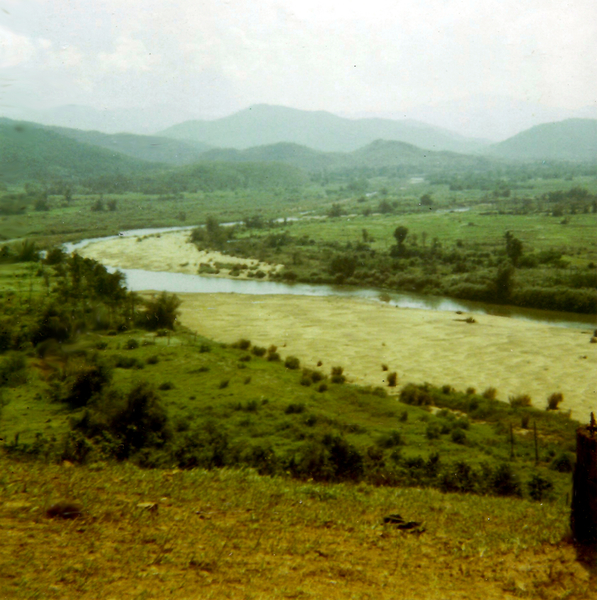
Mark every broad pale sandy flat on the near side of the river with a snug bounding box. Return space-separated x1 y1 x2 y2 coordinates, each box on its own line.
180 294 597 419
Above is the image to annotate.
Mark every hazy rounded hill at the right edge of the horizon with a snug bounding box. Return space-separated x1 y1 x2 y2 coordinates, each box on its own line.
484 119 597 162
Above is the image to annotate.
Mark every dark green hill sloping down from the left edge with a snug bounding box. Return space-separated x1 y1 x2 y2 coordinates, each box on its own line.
0 119 159 183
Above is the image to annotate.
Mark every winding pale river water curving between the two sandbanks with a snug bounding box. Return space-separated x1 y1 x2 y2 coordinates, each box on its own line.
64 227 597 329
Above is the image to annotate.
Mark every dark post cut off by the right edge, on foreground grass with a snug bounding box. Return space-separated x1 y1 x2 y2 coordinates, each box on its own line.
570 413 597 544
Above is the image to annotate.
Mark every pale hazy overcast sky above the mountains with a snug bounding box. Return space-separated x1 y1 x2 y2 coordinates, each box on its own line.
0 0 597 116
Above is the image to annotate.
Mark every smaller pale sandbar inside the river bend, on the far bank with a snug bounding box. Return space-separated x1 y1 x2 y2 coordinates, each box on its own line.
77 231 281 279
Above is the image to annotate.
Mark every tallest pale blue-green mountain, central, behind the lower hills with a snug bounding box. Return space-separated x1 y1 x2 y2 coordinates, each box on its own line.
159 104 487 153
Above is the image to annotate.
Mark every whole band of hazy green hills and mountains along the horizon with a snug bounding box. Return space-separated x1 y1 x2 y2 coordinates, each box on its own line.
0 105 597 182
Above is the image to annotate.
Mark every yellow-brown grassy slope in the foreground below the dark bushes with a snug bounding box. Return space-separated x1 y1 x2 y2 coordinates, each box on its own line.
0 458 597 600
